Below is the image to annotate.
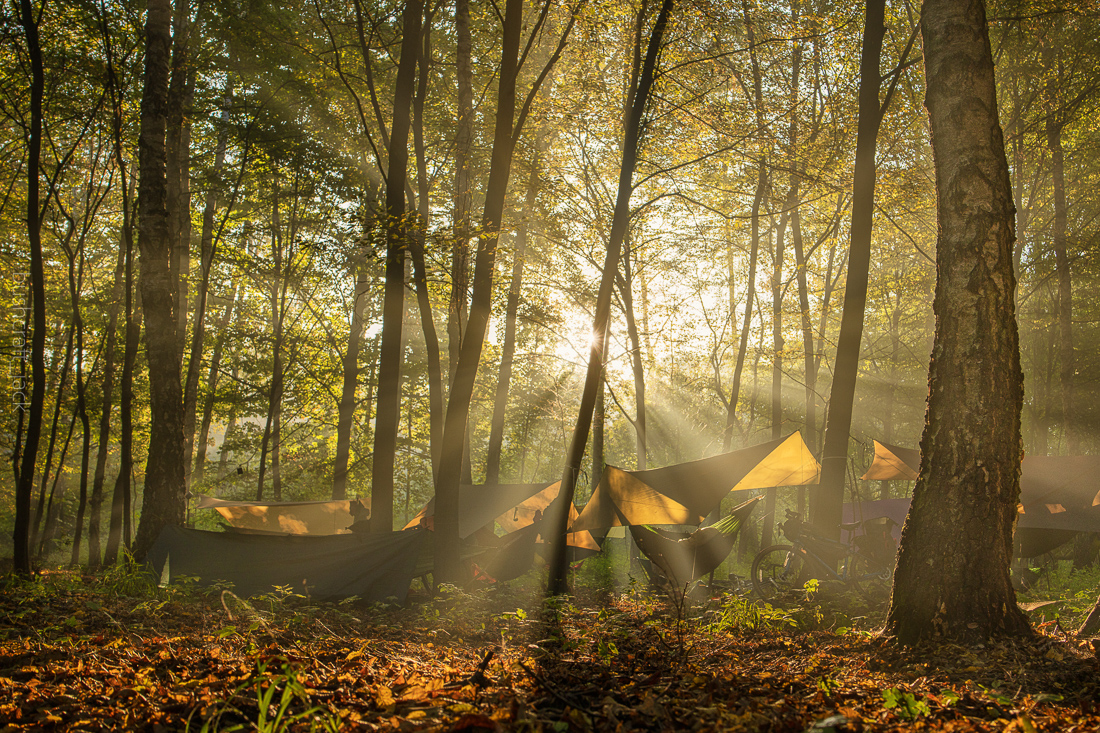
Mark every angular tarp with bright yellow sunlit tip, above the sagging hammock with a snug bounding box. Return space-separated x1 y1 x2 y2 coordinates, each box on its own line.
570 433 821 532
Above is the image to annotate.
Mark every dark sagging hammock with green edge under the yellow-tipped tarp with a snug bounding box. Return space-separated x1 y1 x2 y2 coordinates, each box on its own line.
630 496 760 588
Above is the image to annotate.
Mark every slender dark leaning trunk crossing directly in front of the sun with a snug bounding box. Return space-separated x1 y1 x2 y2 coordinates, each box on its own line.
547 0 673 594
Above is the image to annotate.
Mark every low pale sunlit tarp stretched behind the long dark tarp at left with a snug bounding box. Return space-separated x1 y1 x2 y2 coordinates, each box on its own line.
198 496 371 535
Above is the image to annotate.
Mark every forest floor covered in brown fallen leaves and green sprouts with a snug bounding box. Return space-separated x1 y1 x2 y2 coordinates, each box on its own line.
0 571 1100 733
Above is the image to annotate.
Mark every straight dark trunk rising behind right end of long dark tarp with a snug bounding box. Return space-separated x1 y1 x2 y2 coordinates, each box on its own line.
371 0 420 533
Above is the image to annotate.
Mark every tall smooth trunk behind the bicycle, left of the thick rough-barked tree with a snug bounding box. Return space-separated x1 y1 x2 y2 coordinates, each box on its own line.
810 0 886 539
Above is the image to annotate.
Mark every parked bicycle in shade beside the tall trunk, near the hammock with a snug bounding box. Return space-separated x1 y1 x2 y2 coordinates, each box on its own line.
752 510 897 602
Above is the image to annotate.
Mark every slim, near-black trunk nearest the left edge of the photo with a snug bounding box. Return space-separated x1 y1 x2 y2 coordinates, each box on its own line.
12 0 46 576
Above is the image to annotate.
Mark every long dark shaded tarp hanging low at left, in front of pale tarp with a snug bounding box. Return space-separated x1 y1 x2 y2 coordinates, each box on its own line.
147 526 426 602
